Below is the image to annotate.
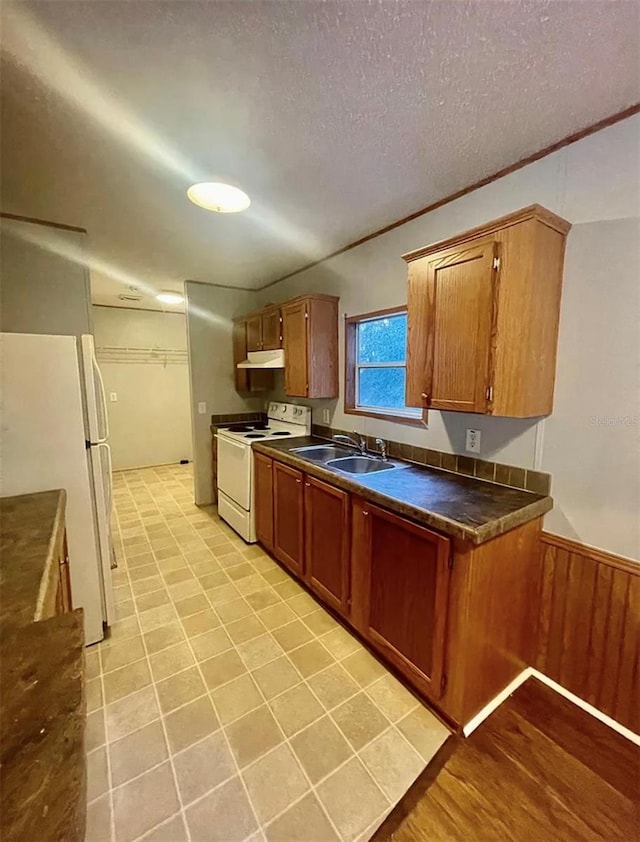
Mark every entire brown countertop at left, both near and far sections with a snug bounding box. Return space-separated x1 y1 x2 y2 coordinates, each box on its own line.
0 490 86 842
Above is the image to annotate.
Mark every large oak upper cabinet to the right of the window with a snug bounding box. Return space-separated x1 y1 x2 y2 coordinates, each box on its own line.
404 205 571 418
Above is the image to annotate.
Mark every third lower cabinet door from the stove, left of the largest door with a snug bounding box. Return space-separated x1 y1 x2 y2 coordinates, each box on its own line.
304 476 351 616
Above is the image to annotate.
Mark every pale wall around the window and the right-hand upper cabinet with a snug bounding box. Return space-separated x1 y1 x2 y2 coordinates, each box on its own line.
258 111 640 558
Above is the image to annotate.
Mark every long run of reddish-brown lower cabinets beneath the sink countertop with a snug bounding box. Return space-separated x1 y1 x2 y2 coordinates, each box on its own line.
255 454 541 727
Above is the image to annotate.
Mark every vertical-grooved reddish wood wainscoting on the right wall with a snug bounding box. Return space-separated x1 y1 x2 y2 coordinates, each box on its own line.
535 532 640 733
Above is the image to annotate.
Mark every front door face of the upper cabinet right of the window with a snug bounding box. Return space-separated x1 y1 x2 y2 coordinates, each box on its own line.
407 240 497 412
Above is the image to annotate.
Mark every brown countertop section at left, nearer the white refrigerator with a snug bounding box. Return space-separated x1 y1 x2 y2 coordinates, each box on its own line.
0 489 67 629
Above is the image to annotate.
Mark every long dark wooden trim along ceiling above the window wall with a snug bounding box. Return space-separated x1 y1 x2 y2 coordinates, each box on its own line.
258 102 640 290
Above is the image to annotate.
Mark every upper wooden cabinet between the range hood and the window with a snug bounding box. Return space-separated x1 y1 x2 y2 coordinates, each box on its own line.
282 295 339 398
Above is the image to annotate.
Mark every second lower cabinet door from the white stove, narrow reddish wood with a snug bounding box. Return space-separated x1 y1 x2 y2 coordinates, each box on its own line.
273 462 304 576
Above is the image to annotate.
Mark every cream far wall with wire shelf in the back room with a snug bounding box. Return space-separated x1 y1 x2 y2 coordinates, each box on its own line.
93 306 192 470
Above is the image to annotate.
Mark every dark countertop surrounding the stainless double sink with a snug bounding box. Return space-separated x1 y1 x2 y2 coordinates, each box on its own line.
252 436 553 544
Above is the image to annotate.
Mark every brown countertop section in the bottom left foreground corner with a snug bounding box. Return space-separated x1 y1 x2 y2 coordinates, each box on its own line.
0 609 86 842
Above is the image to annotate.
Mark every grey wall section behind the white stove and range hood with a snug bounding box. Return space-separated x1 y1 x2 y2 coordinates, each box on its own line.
185 281 265 505
